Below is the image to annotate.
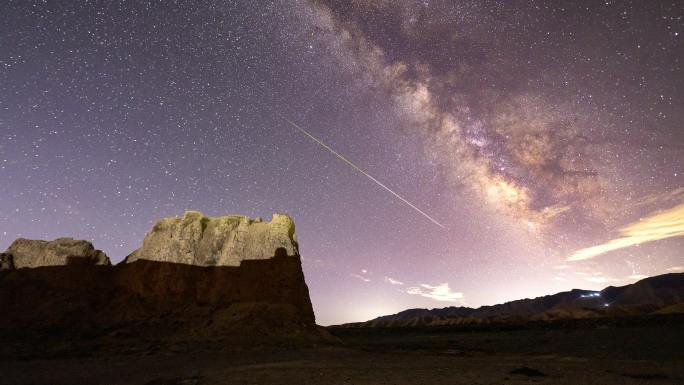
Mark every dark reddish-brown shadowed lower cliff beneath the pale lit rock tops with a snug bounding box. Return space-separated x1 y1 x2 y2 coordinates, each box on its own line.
0 252 334 358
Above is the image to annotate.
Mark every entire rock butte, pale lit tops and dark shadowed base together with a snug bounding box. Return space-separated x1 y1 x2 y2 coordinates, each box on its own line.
0 211 337 357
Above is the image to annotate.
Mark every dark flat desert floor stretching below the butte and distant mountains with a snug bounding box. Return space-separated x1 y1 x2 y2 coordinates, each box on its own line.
0 315 684 384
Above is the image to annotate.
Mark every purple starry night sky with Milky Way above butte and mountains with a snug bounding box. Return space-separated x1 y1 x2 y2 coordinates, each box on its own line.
0 0 684 325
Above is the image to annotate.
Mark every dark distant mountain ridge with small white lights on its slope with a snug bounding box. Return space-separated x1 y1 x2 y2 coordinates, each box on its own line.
332 273 684 328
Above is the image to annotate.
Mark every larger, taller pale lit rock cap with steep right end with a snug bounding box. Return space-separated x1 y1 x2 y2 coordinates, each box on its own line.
126 211 299 266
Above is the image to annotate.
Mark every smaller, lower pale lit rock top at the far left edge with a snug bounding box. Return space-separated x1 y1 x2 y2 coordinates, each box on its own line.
0 238 112 270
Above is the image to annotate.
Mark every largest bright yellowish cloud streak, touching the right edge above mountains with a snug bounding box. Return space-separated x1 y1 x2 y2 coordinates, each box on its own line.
567 204 684 261
